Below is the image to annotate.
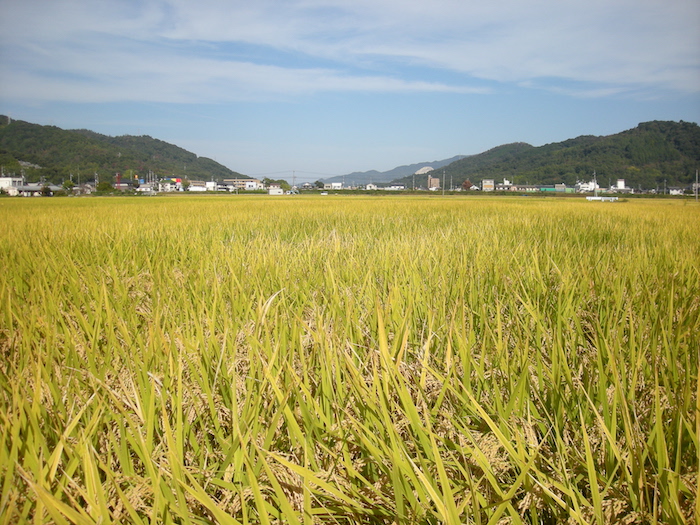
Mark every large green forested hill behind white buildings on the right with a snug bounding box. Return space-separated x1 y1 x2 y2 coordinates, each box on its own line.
399 121 700 189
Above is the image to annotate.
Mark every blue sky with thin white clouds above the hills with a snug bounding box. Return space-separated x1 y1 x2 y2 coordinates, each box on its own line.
0 0 700 180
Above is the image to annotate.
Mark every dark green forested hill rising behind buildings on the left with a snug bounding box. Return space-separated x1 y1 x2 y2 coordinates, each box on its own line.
0 116 241 183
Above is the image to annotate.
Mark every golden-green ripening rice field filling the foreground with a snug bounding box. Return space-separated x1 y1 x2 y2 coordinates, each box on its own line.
0 196 700 525
